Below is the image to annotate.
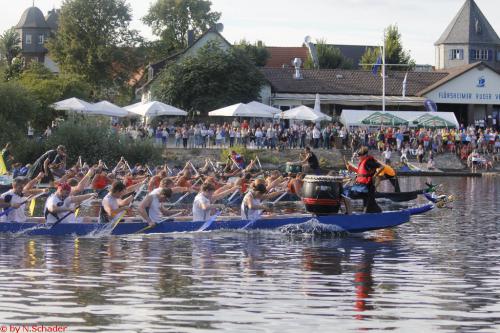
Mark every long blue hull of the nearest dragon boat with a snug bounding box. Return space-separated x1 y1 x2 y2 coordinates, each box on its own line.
0 203 434 236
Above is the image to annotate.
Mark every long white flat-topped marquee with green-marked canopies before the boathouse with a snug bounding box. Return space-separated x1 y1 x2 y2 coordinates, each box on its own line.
340 110 459 128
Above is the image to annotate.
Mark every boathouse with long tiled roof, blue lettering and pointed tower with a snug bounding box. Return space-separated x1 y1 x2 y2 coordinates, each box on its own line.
261 0 500 127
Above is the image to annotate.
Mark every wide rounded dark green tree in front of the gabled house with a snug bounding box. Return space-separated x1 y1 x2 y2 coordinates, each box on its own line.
152 43 264 113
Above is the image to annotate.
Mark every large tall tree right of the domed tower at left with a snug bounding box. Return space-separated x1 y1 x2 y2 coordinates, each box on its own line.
47 0 141 94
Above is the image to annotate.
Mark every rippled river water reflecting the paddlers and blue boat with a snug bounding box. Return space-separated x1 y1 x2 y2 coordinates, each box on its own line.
0 177 500 332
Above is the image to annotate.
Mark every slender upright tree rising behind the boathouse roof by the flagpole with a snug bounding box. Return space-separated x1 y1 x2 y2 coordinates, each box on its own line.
361 25 415 70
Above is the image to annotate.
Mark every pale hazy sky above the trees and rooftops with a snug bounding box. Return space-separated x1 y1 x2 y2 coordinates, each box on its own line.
0 0 500 65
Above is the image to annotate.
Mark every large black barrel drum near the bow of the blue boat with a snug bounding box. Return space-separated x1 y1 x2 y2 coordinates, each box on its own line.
302 175 343 215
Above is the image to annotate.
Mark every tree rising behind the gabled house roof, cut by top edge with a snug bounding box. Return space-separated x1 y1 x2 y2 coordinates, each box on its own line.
143 0 221 55
